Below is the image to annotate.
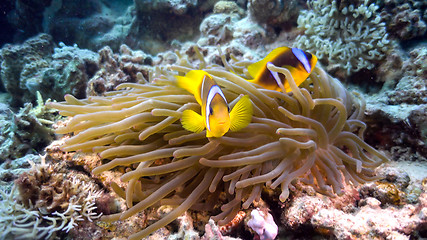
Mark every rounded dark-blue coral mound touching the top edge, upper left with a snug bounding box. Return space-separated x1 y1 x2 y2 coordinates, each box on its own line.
43 0 134 51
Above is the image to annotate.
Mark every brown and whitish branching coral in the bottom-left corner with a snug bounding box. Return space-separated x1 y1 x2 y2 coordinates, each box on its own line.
0 158 107 239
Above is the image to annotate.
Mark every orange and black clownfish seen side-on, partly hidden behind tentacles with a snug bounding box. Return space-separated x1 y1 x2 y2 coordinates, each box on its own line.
248 47 317 92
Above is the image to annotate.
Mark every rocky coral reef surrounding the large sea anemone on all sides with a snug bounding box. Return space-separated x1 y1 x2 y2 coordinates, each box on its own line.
0 0 427 239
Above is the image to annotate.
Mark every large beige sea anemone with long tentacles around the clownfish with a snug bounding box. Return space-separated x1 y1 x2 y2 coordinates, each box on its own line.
50 47 387 239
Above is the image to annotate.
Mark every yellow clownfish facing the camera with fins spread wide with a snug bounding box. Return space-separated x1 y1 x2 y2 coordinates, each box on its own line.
175 70 253 137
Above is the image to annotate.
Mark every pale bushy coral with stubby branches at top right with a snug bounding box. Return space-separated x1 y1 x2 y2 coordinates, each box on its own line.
296 0 391 75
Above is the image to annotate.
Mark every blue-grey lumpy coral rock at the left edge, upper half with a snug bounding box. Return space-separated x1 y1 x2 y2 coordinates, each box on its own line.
0 34 98 107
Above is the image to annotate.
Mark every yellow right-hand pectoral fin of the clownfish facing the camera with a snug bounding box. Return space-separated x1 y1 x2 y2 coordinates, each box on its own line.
230 95 253 132
